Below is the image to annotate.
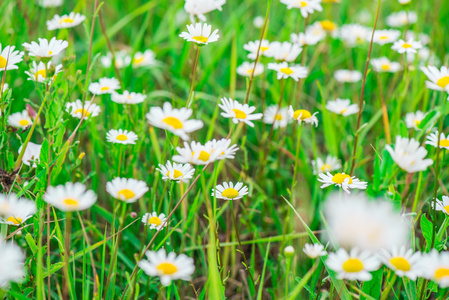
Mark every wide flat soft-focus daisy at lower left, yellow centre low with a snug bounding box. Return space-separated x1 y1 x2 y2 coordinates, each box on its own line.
43 182 97 212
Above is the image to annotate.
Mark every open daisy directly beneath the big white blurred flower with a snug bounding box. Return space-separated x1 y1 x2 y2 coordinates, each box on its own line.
326 248 380 281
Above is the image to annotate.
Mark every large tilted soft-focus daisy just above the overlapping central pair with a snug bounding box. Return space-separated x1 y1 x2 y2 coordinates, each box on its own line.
146 102 204 140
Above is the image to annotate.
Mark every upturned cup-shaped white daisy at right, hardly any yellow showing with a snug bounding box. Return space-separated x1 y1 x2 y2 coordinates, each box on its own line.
385 136 433 173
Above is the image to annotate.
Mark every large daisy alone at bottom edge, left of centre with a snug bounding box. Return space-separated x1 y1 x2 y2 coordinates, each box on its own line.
137 249 195 286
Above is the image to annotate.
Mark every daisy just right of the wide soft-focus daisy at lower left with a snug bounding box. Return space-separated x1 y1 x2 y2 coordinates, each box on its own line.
106 177 148 203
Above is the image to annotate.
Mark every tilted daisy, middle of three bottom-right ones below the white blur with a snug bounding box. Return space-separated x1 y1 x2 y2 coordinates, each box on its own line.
379 246 421 280
